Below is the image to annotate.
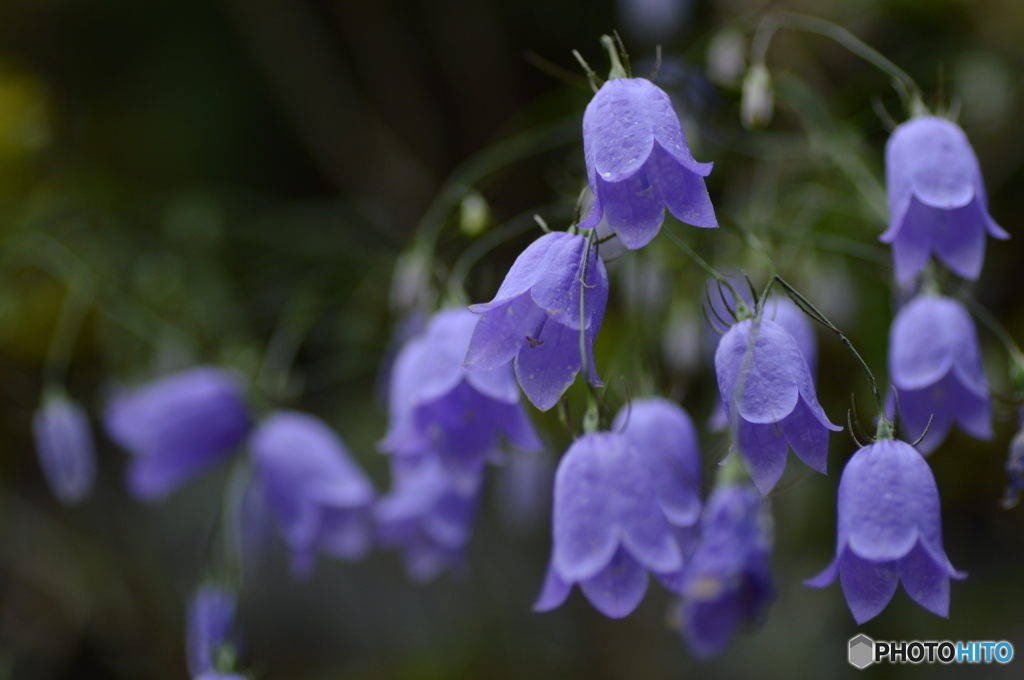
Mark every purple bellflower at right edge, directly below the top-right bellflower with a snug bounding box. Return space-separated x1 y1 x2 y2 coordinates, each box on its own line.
889 295 992 454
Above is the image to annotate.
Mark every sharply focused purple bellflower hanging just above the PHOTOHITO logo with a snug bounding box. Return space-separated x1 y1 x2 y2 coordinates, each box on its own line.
807 439 967 624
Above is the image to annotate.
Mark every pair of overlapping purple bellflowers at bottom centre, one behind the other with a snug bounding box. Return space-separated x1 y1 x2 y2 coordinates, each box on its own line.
534 399 700 619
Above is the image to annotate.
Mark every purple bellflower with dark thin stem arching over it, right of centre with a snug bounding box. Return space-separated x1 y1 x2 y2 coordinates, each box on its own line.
715 318 843 494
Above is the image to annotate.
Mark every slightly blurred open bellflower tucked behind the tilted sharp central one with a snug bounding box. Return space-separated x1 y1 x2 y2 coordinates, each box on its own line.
380 307 544 487
